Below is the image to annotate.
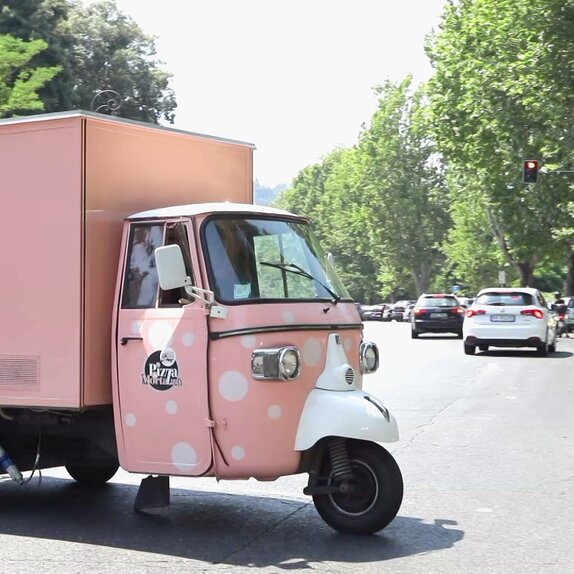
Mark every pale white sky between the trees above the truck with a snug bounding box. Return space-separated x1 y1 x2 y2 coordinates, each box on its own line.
109 0 446 187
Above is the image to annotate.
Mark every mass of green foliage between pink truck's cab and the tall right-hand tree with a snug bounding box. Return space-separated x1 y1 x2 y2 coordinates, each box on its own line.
280 78 449 302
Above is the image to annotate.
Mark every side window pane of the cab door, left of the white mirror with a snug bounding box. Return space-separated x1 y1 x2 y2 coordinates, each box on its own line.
122 223 164 309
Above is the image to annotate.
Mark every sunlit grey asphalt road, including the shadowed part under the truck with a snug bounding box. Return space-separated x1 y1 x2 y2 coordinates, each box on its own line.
0 323 574 574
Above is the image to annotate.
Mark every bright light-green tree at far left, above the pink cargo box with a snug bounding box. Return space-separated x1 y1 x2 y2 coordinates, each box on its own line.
0 34 59 117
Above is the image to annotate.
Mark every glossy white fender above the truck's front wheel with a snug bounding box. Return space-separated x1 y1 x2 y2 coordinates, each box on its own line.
295 388 399 450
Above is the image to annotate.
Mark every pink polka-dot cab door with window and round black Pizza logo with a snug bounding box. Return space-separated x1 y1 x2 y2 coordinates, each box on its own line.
114 220 212 476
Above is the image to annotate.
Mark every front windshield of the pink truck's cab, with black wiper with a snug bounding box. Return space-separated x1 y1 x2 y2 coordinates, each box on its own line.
203 216 350 302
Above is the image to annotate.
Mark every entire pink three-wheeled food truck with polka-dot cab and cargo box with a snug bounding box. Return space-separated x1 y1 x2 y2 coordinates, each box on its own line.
0 111 403 534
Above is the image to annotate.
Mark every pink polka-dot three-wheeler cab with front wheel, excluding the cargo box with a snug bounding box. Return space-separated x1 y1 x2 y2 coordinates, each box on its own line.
113 203 403 534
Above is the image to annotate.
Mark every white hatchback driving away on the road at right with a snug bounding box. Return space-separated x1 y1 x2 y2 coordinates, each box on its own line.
462 287 556 356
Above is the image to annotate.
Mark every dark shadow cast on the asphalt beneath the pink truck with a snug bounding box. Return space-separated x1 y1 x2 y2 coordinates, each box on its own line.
0 478 464 570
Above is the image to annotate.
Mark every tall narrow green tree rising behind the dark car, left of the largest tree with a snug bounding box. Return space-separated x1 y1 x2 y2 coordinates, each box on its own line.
358 77 450 297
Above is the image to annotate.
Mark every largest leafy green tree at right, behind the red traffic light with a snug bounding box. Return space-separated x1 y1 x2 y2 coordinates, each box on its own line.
428 0 574 285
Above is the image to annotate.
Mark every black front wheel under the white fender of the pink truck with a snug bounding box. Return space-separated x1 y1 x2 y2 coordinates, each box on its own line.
313 441 403 534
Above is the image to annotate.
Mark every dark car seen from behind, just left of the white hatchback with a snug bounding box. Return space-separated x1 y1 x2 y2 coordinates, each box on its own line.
411 293 465 339
